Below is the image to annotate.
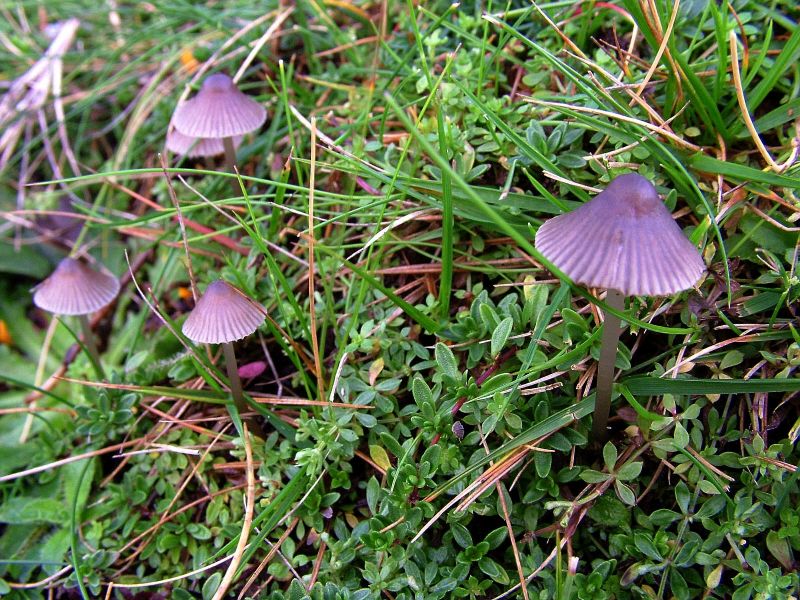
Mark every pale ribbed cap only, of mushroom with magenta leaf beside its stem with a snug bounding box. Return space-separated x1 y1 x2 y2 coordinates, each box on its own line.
183 279 266 344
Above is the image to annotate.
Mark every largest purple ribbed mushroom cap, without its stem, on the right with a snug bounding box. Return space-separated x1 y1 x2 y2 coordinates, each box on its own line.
536 173 706 296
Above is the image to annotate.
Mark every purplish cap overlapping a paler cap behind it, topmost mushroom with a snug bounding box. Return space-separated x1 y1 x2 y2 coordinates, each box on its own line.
172 73 267 138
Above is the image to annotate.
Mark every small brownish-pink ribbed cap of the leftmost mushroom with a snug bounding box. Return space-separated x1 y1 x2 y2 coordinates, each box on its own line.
33 258 119 315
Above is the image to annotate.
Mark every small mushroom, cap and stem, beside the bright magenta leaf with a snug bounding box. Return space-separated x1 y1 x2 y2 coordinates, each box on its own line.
182 279 266 436
